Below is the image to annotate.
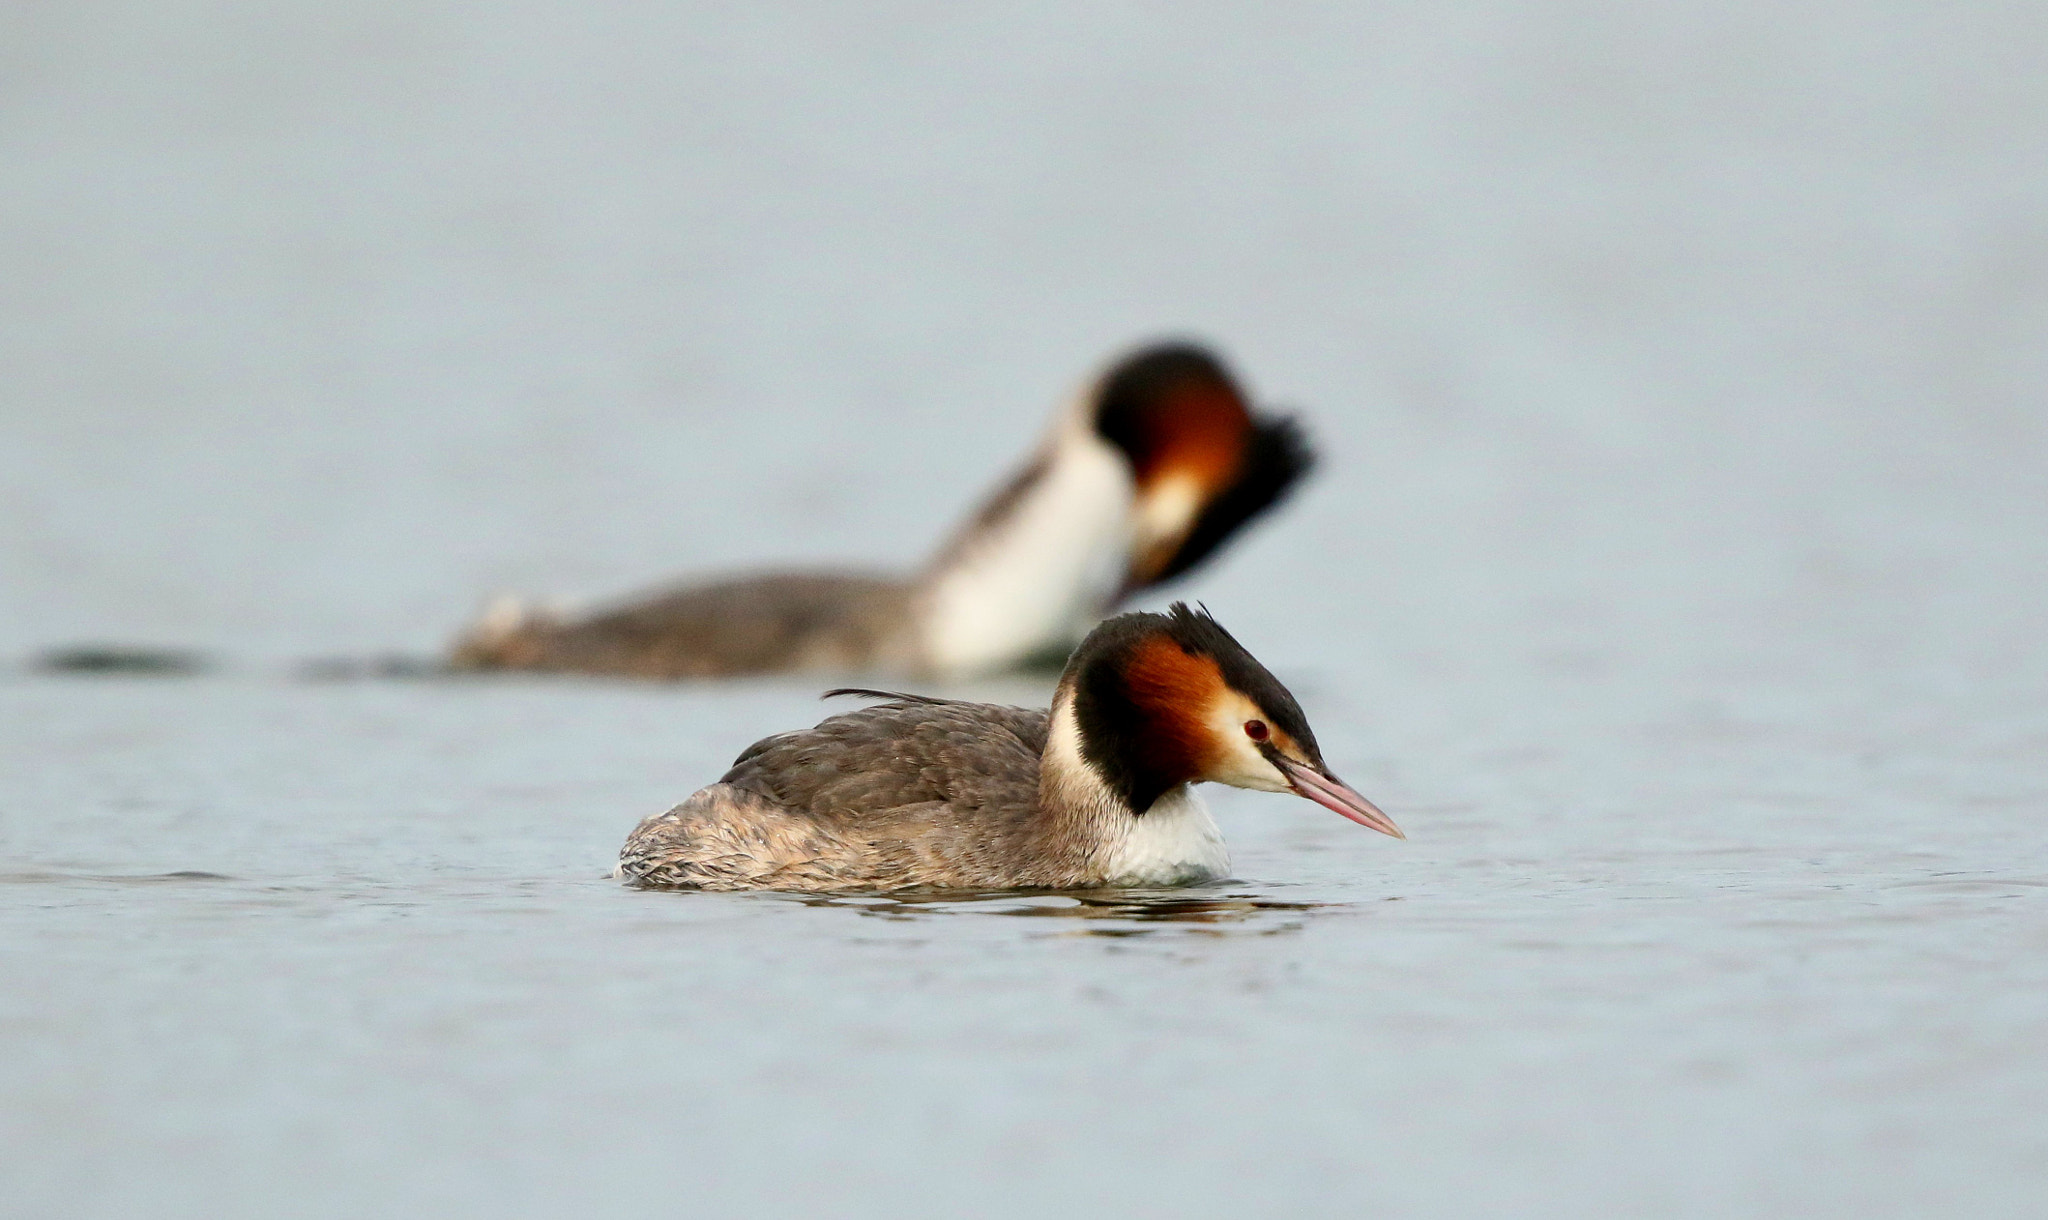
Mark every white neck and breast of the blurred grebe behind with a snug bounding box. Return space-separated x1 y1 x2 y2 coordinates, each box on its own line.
920 409 1135 676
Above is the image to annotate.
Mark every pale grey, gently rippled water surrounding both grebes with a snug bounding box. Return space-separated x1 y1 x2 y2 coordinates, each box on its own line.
0 0 2048 1216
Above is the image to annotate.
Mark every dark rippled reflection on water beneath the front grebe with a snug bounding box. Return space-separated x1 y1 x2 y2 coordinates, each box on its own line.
799 890 1348 935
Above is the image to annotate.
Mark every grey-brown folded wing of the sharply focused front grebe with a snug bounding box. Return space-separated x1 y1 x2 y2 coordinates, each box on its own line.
721 702 1044 819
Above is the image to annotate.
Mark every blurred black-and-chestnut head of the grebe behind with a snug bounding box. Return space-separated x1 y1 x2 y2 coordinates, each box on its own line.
1094 344 1315 598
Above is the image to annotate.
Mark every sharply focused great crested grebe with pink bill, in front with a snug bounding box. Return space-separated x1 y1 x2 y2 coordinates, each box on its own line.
618 602 1405 890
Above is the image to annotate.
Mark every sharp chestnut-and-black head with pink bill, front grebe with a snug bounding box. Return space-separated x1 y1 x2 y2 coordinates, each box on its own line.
1059 602 1407 839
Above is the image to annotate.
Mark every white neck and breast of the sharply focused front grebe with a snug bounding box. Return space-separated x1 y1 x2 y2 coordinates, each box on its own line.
1040 690 1231 886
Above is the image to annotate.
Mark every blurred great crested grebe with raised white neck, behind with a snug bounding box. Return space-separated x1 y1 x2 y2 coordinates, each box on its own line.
451 344 1313 678
